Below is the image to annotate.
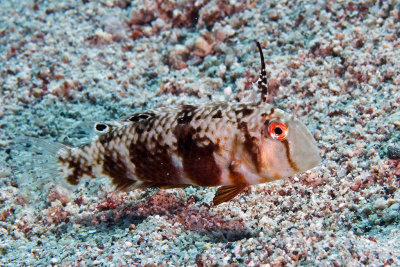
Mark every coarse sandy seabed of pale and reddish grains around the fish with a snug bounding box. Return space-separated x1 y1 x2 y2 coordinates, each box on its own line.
0 0 400 266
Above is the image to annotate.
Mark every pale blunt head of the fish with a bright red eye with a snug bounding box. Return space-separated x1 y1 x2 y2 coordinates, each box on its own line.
250 105 321 182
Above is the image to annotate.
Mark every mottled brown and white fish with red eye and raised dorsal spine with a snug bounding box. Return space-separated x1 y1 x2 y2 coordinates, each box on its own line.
30 41 321 205
